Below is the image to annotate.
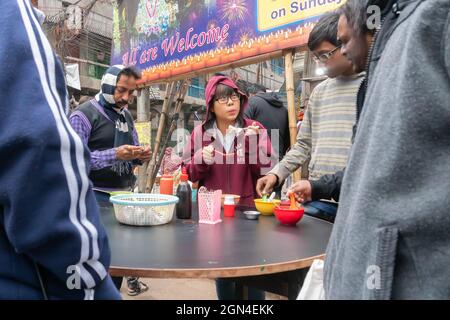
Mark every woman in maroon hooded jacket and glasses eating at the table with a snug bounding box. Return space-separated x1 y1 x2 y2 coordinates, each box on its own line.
183 76 273 300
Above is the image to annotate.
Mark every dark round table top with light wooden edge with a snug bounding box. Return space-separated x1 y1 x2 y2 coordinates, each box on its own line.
101 204 332 278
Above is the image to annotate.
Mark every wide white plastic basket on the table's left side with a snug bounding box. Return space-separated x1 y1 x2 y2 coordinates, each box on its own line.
109 193 178 226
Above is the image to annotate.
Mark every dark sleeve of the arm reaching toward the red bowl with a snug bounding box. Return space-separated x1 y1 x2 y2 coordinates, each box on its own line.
310 169 345 201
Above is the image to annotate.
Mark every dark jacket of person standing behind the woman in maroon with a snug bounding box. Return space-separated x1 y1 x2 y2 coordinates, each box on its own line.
244 92 290 159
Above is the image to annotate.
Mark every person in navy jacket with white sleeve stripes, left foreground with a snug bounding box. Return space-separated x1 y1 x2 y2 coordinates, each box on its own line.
0 0 120 299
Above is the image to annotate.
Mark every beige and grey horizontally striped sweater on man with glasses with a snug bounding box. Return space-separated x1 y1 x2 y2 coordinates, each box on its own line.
270 73 364 182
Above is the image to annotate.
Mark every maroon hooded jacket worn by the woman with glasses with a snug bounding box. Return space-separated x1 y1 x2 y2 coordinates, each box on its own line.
183 76 274 207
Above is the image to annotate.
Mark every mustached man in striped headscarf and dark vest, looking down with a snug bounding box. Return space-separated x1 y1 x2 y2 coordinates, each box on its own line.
69 65 151 295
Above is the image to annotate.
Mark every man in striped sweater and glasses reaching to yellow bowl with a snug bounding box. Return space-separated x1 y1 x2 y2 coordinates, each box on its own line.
256 13 363 220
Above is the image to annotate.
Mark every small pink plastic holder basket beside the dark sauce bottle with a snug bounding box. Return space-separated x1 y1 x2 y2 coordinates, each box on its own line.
197 187 222 224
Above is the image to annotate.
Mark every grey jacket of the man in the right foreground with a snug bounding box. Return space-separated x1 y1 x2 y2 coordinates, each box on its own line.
324 0 450 299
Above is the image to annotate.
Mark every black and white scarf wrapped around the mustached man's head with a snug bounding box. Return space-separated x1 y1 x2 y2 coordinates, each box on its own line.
95 65 134 176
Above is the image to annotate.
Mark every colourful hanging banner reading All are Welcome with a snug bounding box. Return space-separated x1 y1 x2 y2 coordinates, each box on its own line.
112 0 346 82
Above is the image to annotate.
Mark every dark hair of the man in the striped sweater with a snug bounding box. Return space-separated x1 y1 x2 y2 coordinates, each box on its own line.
308 12 341 51
